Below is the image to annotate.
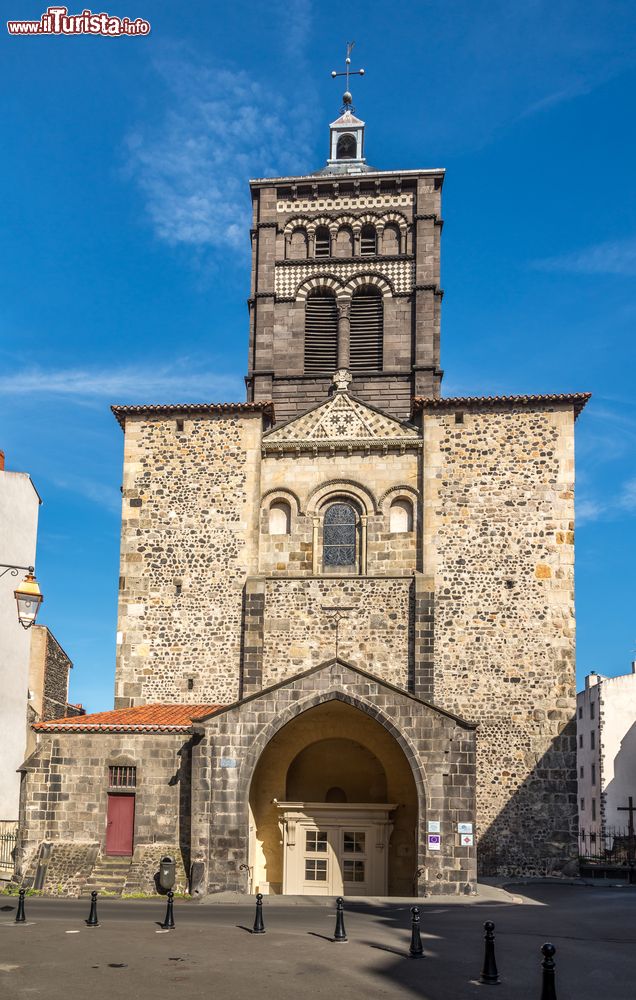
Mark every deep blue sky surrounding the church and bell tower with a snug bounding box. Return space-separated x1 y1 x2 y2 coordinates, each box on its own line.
0 0 636 710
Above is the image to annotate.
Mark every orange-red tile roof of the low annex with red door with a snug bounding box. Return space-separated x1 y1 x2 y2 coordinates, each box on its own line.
32 704 223 733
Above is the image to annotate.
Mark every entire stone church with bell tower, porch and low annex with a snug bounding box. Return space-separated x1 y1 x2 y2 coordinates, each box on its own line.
18 93 588 896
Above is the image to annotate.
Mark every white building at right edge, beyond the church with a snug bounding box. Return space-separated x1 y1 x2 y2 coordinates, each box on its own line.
576 662 636 835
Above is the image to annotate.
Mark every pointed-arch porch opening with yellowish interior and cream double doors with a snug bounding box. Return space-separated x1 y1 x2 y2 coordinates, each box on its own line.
249 700 418 896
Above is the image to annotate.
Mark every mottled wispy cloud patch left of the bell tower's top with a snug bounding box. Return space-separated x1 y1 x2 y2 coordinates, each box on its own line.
126 50 310 251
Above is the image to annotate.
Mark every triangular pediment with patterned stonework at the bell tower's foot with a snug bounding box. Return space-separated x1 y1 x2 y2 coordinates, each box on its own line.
264 392 419 445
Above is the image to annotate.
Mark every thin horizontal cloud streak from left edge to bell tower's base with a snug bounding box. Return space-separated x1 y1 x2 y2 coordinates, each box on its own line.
0 360 244 402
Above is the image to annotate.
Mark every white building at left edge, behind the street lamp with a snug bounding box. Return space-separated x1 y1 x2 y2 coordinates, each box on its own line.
0 452 41 821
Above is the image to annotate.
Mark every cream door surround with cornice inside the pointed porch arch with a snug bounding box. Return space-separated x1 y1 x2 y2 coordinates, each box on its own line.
276 802 397 896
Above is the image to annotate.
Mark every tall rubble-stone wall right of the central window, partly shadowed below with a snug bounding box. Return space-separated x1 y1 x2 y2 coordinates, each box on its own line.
423 405 576 872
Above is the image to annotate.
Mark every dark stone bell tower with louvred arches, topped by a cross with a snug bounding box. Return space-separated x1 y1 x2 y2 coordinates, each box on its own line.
246 43 444 422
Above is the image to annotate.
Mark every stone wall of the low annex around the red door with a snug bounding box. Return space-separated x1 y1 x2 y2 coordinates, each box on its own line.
18 733 191 884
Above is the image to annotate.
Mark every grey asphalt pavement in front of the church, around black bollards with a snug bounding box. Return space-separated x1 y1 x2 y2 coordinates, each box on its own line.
0 885 636 1000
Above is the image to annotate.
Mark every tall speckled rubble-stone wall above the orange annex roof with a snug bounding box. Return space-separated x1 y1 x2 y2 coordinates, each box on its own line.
115 413 262 707
